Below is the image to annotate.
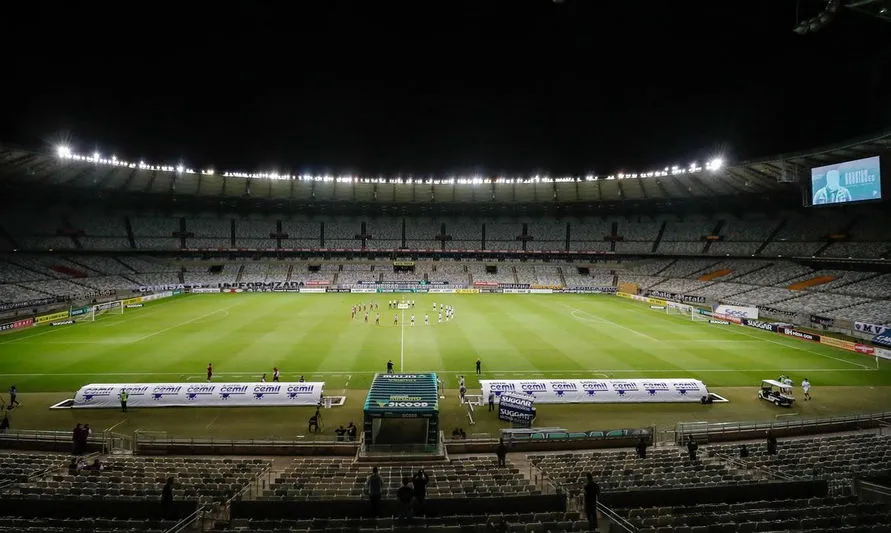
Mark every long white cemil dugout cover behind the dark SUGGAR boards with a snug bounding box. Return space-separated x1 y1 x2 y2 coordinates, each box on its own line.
480 379 708 403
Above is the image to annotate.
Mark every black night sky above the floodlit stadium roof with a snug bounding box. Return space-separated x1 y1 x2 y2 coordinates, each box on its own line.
0 0 891 174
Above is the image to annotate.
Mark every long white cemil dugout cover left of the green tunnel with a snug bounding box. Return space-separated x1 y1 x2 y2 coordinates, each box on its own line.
72 382 325 409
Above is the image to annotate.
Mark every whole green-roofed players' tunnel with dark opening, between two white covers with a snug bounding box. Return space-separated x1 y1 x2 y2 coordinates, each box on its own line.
363 372 439 452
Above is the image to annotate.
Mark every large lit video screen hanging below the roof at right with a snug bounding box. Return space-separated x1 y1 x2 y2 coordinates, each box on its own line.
810 156 882 205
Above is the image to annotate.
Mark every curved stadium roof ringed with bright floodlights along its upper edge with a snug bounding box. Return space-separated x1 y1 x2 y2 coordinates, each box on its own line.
0 131 891 205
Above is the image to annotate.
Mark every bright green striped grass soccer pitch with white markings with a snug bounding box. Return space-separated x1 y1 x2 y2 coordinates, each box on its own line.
0 293 891 436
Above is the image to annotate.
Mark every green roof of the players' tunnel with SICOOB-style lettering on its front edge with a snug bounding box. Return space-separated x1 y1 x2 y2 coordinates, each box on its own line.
365 372 439 418
